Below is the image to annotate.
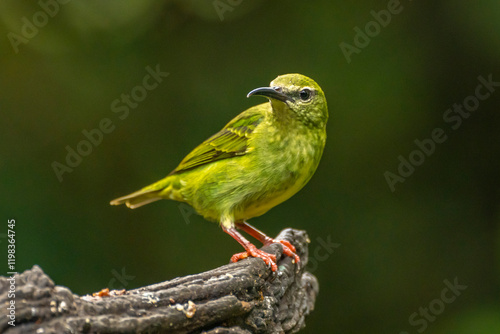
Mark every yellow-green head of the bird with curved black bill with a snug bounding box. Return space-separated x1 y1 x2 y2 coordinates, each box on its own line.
247 74 328 128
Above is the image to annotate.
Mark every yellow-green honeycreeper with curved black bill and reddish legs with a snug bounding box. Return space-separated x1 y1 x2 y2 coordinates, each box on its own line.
111 74 328 271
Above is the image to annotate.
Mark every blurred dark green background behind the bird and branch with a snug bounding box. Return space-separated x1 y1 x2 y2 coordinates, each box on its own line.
0 0 500 334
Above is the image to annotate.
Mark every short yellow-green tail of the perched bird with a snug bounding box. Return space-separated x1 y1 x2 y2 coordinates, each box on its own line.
110 175 183 209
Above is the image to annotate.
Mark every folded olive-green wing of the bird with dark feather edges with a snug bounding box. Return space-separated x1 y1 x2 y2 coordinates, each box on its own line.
170 108 264 175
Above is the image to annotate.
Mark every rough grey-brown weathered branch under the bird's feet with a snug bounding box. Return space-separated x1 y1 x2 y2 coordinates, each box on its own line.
0 229 318 334
